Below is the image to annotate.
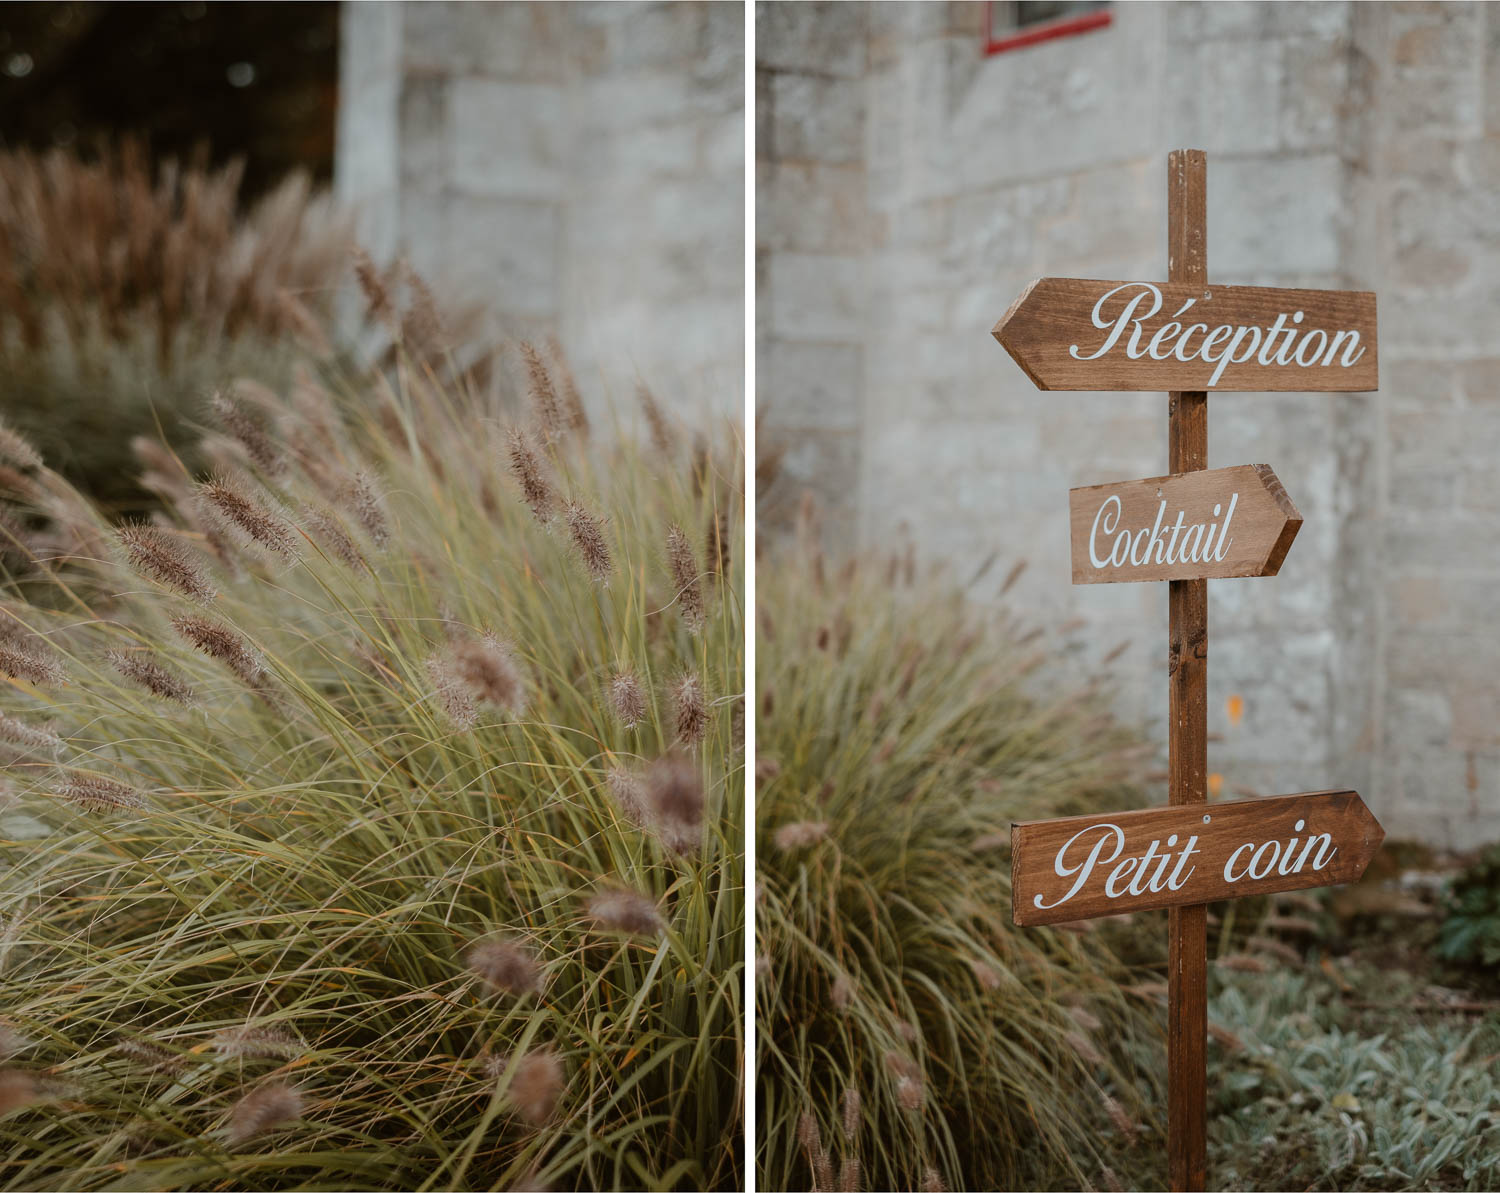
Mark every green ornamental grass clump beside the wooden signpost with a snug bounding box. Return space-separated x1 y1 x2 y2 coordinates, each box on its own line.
755 521 1164 1190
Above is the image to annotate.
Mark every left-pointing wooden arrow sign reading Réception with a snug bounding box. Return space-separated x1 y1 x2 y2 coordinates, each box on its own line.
993 278 1379 390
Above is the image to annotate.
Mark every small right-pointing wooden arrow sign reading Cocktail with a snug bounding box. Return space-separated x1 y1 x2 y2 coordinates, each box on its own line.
1068 464 1302 584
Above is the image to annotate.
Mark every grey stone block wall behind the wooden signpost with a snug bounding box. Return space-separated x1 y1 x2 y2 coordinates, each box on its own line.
756 3 1500 846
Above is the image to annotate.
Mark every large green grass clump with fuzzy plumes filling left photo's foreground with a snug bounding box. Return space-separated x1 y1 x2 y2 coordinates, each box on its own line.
0 331 744 1190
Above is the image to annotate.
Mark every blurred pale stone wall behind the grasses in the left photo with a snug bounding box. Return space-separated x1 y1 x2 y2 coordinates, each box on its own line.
336 0 746 420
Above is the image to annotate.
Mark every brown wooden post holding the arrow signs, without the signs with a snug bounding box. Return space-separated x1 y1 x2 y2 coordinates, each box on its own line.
1167 149 1209 1191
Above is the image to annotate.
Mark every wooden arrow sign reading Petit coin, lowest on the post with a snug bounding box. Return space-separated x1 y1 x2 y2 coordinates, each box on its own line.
1011 791 1386 926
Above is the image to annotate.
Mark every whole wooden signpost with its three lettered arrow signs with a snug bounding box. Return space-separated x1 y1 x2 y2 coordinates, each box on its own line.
995 150 1385 1190
